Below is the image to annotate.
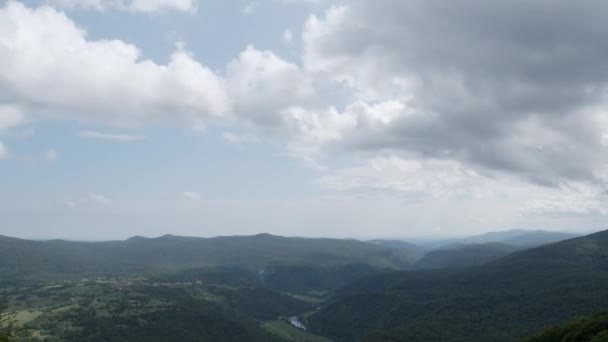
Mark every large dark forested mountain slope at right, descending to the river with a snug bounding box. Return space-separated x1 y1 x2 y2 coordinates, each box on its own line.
309 231 608 341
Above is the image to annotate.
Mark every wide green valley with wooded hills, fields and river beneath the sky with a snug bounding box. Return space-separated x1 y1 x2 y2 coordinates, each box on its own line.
0 228 592 342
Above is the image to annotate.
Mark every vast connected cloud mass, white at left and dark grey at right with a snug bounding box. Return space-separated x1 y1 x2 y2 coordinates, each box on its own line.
5 0 608 222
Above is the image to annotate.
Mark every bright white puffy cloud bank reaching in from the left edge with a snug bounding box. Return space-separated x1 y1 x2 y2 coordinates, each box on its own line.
0 1 229 124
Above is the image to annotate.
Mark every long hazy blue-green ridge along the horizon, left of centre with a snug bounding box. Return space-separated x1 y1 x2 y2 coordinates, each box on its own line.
0 234 416 280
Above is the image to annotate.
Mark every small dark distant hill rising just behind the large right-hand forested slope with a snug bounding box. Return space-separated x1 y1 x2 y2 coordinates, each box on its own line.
416 243 521 269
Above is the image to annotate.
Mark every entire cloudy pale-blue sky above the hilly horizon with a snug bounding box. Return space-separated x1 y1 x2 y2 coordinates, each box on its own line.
0 0 608 240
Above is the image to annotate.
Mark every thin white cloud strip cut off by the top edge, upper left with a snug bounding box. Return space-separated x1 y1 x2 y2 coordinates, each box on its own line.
46 0 198 13
